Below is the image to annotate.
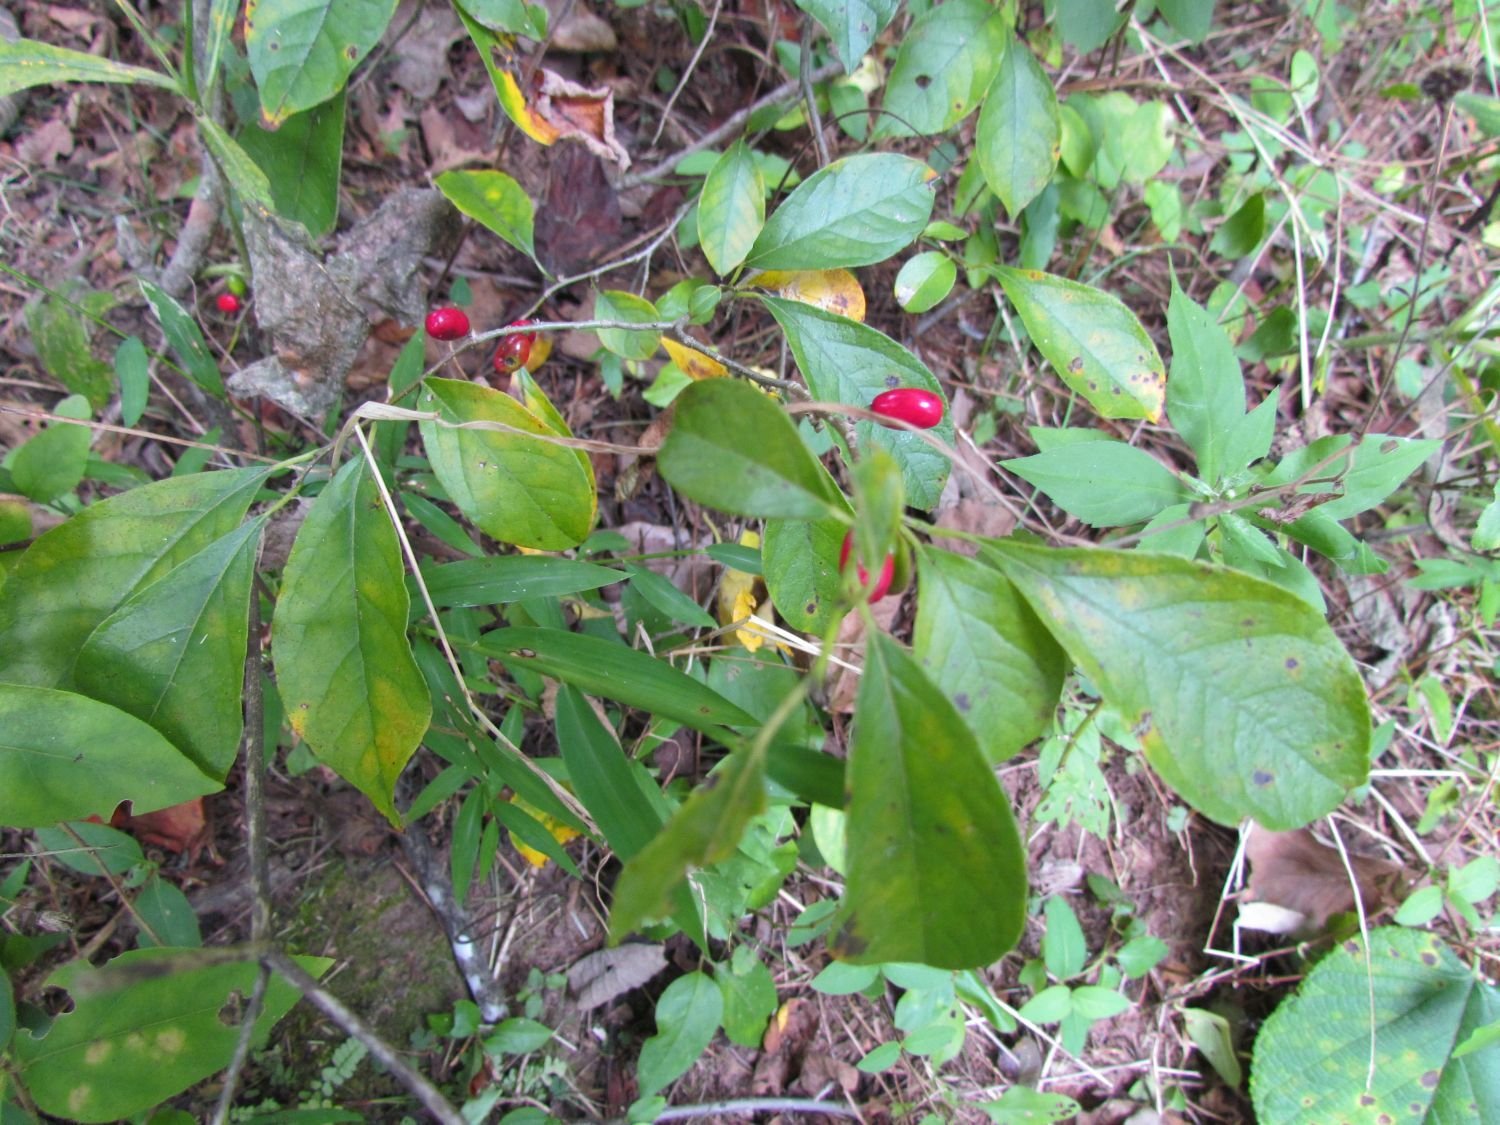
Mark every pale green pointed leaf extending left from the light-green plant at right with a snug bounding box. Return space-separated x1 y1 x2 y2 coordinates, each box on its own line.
1001 441 1193 528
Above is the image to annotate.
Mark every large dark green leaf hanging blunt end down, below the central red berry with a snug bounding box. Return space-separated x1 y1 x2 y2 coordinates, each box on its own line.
833 632 1026 969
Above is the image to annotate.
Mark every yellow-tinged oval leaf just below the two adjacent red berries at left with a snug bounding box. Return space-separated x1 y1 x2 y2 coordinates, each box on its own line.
417 380 599 551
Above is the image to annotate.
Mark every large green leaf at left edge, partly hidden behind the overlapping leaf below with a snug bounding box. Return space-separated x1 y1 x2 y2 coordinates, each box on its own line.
0 470 266 687
